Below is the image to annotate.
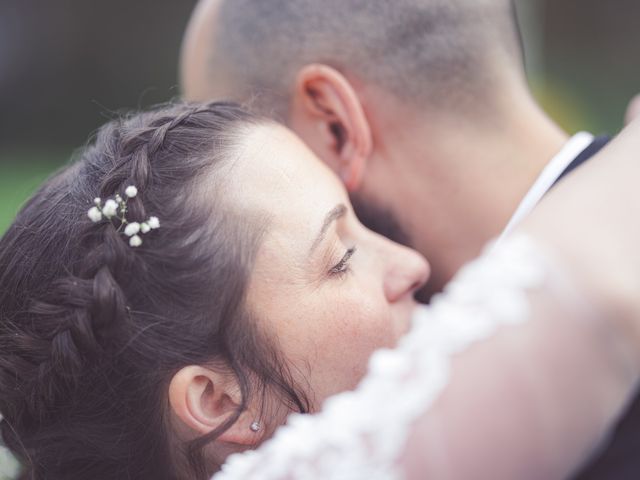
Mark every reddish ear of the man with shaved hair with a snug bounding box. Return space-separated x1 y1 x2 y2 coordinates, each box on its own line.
289 64 373 191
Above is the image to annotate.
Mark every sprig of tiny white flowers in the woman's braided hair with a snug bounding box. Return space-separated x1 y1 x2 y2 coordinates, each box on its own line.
87 185 160 247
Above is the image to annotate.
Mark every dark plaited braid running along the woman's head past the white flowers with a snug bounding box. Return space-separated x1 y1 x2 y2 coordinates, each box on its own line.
12 106 210 413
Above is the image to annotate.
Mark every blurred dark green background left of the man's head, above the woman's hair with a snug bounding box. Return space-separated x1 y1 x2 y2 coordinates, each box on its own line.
0 0 196 236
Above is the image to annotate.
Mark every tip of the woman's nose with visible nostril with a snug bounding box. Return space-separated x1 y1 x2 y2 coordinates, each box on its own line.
384 245 431 303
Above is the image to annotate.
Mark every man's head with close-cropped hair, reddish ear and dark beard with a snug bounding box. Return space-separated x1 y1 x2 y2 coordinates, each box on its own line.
181 0 564 296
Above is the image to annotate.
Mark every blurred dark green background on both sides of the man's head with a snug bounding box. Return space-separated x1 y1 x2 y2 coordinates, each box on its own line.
0 0 640 240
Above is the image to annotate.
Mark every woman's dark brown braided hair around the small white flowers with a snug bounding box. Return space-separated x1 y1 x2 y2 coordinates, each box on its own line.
0 99 308 480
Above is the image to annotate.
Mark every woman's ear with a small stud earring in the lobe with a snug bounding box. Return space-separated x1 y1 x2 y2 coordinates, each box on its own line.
169 365 263 446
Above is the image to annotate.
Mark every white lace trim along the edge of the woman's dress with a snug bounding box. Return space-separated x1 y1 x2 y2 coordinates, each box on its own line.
213 236 547 480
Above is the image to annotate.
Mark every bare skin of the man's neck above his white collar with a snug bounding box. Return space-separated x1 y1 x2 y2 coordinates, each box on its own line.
398 93 568 289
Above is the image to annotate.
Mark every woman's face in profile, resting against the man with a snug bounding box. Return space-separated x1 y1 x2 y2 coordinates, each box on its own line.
233 125 429 409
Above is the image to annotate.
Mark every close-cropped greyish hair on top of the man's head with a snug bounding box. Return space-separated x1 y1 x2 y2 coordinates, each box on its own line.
183 0 520 119
